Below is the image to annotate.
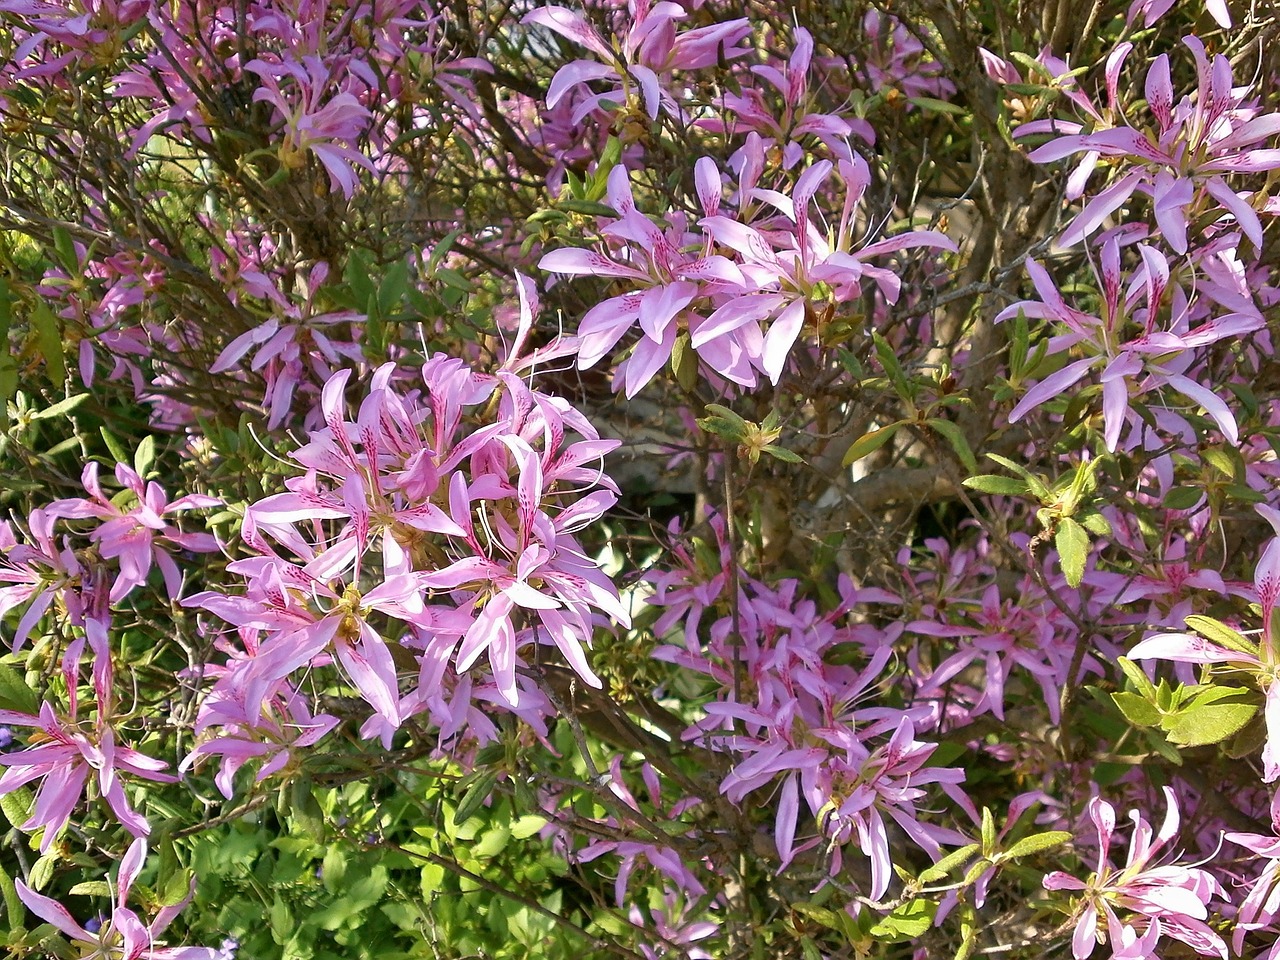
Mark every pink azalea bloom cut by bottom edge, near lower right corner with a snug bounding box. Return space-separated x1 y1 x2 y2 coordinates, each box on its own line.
1044 787 1226 960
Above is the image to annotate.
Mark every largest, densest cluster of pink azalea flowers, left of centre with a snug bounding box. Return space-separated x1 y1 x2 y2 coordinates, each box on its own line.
186 289 630 764
